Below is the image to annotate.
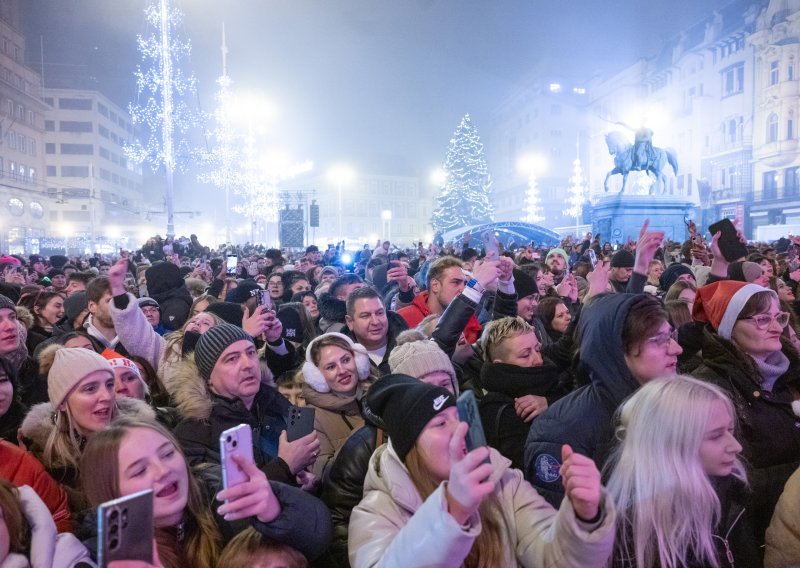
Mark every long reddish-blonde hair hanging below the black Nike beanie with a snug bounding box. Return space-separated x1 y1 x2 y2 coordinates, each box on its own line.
405 445 509 568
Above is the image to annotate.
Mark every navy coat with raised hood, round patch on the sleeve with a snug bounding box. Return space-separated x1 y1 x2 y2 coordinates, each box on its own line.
524 294 641 506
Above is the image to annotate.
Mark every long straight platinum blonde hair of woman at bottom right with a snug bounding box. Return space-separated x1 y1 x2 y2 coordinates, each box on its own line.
606 376 746 568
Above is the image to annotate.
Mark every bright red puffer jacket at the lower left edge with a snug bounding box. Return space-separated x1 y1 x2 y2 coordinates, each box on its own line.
0 440 72 532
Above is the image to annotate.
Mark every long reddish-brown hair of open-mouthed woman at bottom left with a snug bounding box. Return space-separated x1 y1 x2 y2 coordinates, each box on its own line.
81 418 222 568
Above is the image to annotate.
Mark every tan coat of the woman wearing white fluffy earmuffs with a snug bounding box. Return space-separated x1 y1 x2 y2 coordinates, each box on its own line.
303 383 369 483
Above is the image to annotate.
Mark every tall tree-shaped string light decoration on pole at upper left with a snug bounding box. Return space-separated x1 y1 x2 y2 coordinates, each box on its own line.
125 0 204 237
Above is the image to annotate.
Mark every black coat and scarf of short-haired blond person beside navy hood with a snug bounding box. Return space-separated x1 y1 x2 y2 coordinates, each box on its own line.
478 361 569 470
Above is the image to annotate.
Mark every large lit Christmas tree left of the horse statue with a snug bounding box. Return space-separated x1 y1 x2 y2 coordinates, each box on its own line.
431 114 494 234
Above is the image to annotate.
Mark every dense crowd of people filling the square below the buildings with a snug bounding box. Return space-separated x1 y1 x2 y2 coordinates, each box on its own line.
0 222 800 568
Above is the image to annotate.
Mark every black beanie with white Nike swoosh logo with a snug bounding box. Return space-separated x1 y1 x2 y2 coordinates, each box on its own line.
367 374 456 462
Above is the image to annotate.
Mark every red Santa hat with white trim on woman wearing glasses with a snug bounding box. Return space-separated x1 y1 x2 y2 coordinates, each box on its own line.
692 280 778 339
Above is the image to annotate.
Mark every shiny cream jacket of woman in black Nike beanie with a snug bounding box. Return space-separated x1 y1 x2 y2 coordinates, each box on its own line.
348 444 616 568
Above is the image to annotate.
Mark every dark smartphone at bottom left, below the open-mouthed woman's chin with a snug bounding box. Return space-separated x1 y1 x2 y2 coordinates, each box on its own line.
97 489 153 567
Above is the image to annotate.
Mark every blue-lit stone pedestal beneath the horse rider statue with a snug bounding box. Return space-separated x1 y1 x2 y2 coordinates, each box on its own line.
592 195 695 245
